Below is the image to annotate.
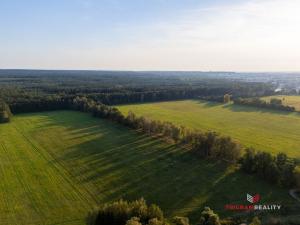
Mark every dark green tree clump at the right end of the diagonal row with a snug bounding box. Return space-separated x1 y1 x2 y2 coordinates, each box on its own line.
241 148 297 187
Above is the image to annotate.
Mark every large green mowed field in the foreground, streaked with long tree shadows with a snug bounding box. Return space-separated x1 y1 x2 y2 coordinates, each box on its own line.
0 110 294 225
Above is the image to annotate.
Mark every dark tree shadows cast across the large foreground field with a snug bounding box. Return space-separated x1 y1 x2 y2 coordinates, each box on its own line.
33 112 288 221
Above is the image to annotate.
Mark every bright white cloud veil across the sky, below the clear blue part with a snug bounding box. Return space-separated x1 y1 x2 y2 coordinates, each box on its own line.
0 0 300 71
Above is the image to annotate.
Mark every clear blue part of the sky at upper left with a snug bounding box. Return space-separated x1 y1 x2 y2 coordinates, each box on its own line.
0 0 207 44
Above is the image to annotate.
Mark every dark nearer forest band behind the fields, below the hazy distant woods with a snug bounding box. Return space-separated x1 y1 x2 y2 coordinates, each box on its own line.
0 87 272 110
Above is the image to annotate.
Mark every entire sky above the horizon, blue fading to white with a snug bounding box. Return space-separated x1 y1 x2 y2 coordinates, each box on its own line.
0 0 300 72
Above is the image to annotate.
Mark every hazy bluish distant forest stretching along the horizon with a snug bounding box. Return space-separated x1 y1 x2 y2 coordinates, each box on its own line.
0 69 276 97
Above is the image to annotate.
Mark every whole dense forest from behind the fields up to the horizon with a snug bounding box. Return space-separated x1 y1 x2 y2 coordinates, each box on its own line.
0 70 275 108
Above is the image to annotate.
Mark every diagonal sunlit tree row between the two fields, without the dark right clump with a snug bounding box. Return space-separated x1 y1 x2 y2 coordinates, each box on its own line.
72 97 241 163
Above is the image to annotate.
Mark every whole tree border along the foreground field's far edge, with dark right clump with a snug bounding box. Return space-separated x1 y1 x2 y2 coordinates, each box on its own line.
5 96 299 186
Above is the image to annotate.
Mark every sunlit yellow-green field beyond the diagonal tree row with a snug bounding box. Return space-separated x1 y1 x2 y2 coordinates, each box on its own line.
118 100 300 158
